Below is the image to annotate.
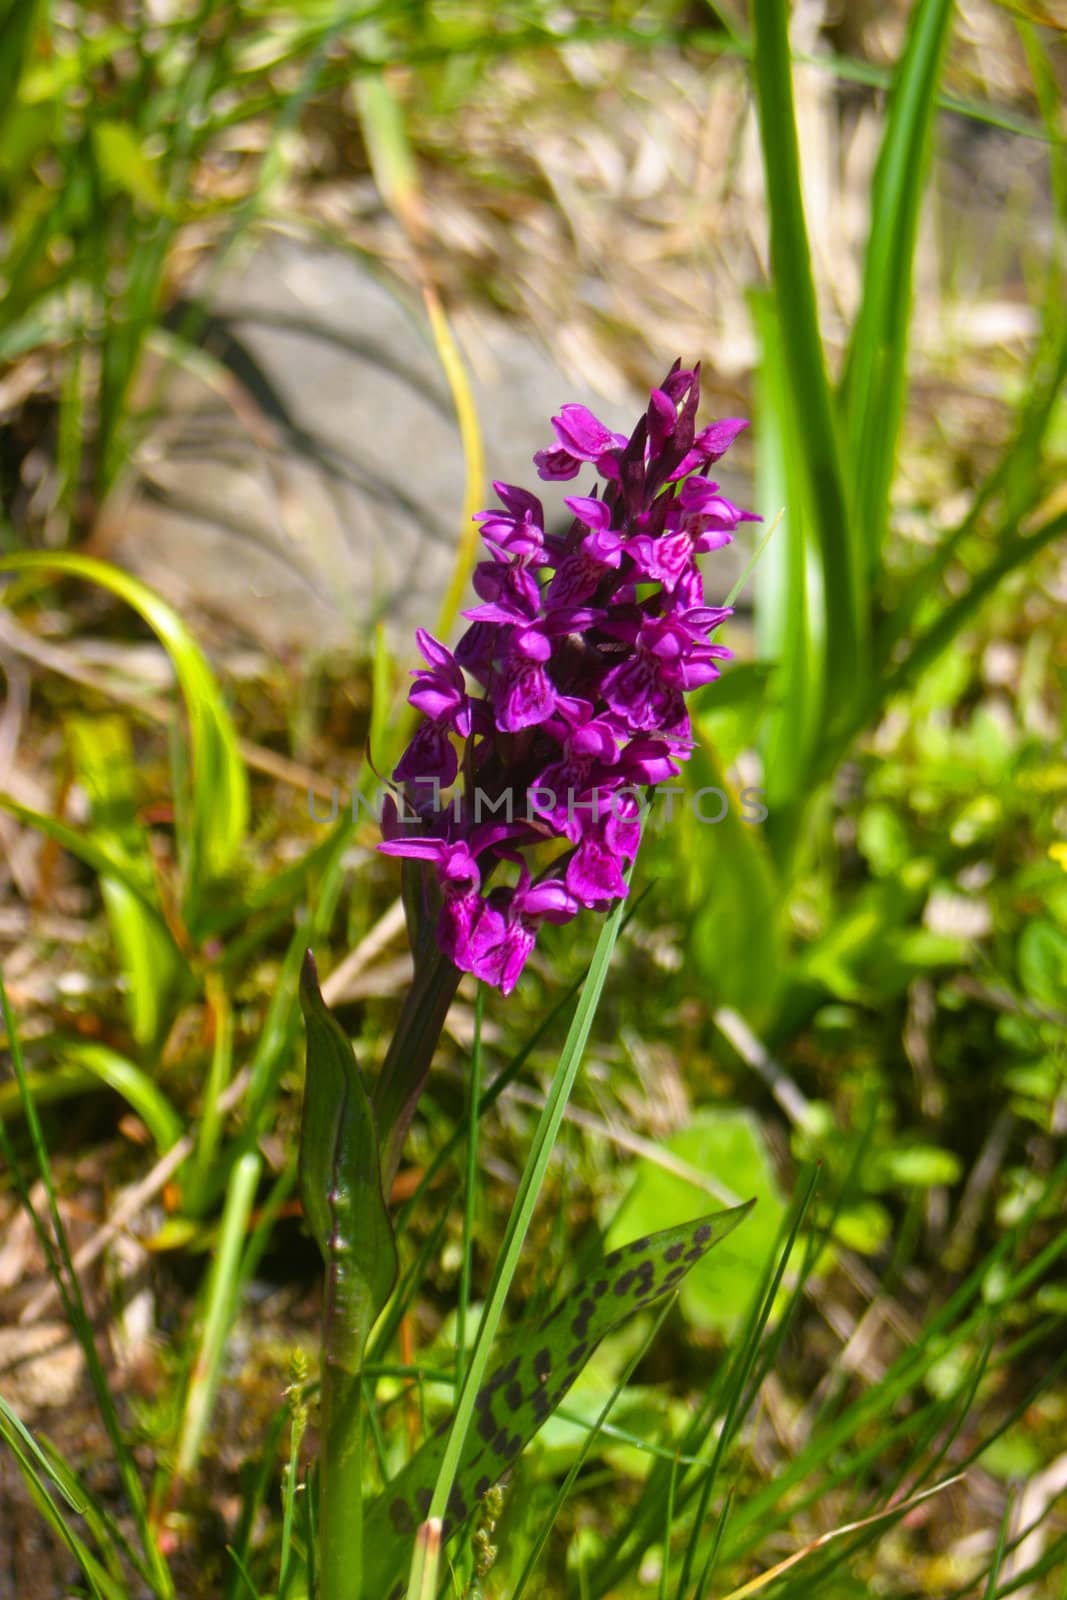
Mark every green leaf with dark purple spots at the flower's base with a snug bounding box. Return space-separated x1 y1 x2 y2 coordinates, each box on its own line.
365 1200 755 1600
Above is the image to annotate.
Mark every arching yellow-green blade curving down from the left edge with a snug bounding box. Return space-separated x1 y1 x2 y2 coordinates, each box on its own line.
0 552 248 922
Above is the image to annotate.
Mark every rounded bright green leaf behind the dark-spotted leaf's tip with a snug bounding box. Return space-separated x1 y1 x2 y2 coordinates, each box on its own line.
608 1107 785 1334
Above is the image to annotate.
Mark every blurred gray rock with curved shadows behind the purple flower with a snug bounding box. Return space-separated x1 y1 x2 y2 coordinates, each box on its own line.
103 240 744 651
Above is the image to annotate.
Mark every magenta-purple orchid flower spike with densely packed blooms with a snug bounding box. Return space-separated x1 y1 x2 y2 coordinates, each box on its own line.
381 363 758 994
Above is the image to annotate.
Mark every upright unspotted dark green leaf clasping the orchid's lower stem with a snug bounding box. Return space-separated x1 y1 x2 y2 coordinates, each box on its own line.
299 950 397 1371
